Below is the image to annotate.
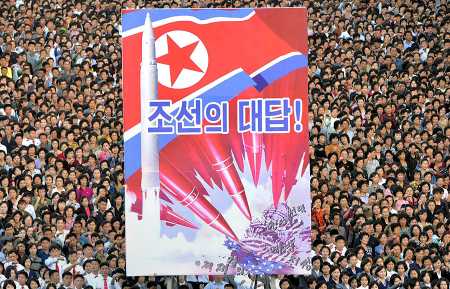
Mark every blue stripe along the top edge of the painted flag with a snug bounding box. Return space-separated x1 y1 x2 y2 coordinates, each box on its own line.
122 9 253 32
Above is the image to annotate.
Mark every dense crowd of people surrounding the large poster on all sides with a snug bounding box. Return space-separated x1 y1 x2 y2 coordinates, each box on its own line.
0 0 450 289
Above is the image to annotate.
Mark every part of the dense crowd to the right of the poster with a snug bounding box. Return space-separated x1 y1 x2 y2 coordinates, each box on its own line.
306 1 450 289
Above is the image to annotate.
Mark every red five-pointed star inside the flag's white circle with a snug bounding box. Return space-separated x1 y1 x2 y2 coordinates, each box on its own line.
157 35 203 85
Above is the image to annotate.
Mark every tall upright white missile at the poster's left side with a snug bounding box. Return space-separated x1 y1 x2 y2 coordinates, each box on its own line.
140 13 159 202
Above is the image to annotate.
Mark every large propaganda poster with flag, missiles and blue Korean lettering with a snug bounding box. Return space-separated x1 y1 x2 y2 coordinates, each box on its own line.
122 8 311 275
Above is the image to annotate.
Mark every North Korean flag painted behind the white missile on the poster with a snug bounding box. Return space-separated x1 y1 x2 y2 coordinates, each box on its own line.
122 8 307 216
